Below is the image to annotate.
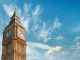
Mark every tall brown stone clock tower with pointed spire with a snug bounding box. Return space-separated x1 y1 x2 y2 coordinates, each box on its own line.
1 11 26 60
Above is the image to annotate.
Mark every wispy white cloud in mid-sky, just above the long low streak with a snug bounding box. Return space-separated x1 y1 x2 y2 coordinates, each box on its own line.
37 23 50 42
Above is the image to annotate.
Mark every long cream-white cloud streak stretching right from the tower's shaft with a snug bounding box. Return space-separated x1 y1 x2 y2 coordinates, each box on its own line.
27 42 62 52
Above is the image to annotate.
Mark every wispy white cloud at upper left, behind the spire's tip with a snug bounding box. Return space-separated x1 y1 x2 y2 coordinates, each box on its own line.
2 4 21 17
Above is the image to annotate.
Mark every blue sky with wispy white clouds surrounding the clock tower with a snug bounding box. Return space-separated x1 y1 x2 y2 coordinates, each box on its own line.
0 0 80 60
